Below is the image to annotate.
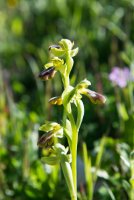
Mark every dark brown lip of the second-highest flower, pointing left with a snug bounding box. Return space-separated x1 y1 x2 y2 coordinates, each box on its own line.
38 67 56 80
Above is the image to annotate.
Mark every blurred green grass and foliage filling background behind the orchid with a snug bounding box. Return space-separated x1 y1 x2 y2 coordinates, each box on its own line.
0 0 134 200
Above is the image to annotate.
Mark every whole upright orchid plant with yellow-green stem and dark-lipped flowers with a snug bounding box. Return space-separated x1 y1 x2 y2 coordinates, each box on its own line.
38 39 106 200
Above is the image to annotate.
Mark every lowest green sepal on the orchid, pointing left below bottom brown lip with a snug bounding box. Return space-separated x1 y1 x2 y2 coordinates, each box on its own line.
41 156 60 165
